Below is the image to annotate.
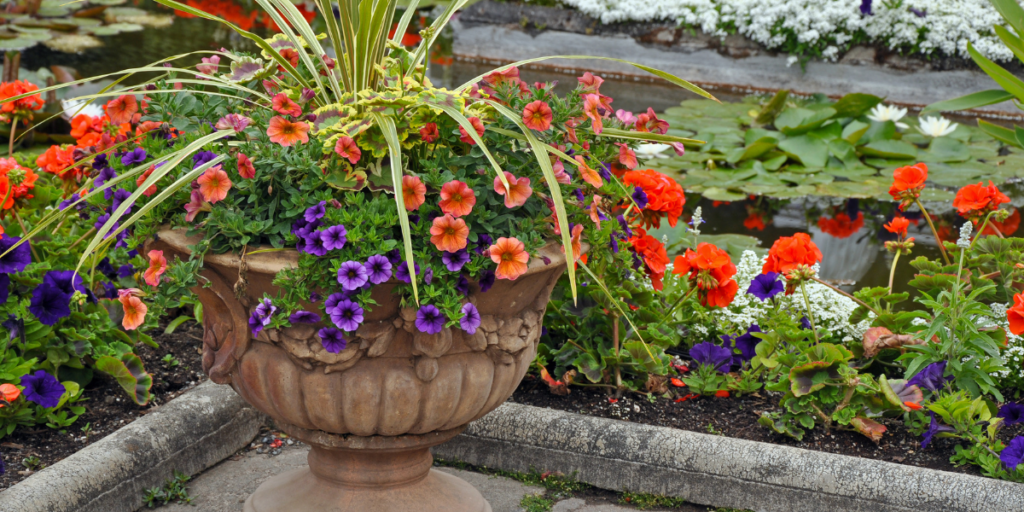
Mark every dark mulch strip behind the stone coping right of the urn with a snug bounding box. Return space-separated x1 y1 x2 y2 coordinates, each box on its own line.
510 375 1024 476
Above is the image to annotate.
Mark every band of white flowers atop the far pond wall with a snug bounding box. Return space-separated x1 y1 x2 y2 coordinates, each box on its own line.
561 0 1013 60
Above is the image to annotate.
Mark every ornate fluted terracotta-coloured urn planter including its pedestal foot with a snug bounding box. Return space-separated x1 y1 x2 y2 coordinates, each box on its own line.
152 230 565 512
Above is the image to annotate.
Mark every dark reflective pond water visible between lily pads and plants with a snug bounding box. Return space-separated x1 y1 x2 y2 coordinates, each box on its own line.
8 3 1011 291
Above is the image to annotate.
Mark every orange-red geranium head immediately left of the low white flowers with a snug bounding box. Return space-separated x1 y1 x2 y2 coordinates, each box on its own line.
672 242 739 307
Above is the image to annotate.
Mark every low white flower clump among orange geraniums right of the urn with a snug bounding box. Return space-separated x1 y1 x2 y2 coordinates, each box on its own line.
713 251 870 341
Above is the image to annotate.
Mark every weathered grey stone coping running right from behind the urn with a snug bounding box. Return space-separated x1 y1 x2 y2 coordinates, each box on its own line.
433 402 1024 512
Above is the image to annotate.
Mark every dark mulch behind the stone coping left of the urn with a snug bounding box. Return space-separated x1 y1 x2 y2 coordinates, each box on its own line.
0 323 206 490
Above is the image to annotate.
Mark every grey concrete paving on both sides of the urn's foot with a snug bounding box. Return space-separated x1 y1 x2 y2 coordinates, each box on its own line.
151 444 707 512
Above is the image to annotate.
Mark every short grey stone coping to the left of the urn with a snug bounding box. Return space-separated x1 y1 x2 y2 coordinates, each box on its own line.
0 381 264 512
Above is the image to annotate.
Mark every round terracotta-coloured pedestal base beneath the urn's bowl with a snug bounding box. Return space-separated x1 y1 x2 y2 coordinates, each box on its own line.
244 424 490 512
